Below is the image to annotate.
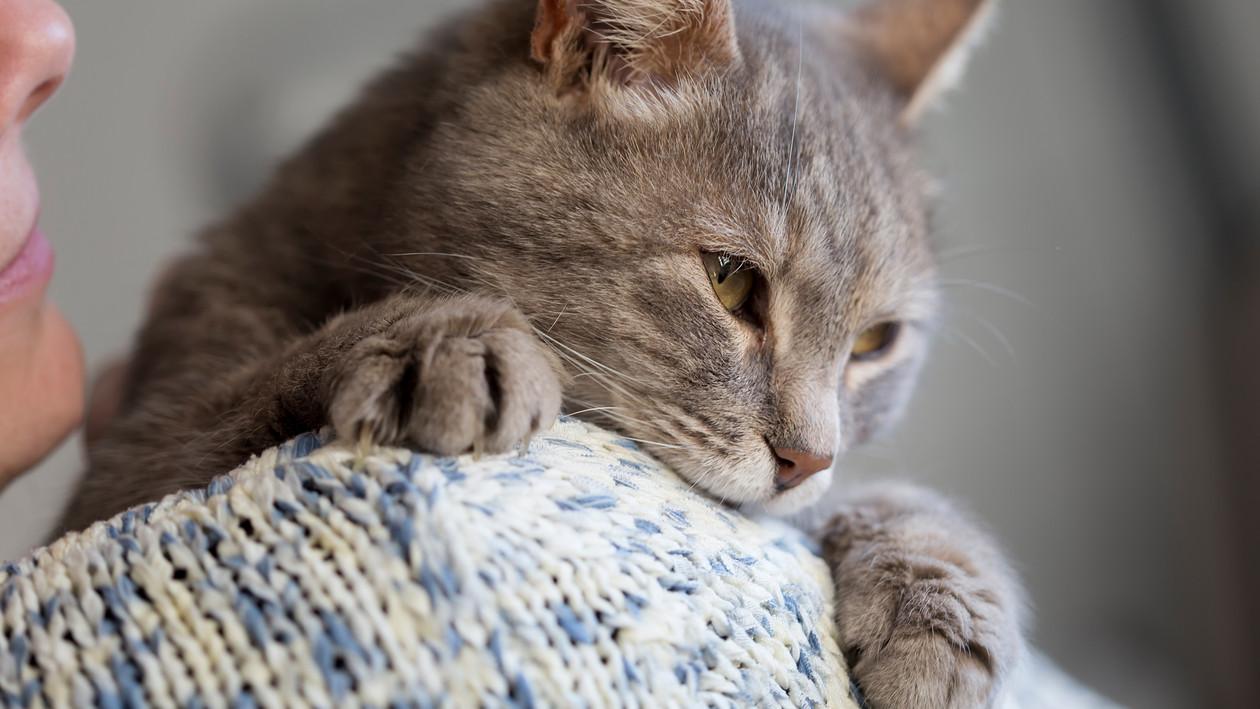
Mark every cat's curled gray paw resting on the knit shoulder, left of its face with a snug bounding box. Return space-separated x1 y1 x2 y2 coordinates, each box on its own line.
325 297 561 455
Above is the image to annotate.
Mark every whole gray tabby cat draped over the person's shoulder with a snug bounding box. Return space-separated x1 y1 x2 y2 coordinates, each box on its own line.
63 0 1023 708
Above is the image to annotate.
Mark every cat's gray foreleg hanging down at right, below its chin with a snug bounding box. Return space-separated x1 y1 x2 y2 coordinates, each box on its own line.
823 484 1024 709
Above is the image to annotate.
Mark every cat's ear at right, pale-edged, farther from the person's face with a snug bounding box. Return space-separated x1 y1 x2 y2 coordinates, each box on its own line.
843 0 997 125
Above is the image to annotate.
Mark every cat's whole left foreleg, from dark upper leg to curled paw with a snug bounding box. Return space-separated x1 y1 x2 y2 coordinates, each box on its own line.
62 295 561 530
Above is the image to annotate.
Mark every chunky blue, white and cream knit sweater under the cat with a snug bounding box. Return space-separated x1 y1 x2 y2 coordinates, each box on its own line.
0 421 1123 709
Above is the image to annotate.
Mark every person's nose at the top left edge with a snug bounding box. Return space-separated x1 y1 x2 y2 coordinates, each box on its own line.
0 0 74 135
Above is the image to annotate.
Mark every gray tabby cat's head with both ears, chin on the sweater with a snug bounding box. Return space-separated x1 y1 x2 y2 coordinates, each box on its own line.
396 0 989 511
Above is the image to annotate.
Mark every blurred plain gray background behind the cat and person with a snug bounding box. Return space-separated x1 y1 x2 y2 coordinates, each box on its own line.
0 0 1260 708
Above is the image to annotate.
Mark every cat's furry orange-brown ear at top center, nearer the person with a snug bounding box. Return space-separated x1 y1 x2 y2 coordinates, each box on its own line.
530 0 740 92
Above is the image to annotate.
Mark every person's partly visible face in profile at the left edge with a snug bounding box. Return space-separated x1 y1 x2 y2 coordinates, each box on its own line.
0 0 83 486
